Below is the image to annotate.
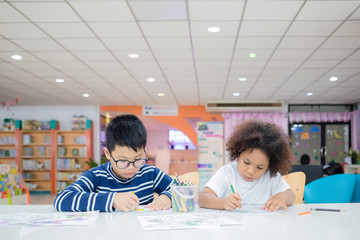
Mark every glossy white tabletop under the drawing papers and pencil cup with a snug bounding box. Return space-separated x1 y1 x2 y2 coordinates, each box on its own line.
0 203 360 240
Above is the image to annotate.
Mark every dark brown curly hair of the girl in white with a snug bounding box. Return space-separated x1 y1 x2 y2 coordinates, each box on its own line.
226 120 292 177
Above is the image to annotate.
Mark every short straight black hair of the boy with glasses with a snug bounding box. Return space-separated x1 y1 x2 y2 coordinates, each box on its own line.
106 114 147 152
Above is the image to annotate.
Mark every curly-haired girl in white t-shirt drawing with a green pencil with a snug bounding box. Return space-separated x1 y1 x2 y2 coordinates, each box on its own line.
199 120 295 211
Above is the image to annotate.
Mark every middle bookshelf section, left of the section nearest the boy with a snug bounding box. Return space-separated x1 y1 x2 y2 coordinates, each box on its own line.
20 130 55 191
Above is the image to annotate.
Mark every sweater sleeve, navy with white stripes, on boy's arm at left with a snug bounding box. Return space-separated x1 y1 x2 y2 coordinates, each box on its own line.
54 171 115 212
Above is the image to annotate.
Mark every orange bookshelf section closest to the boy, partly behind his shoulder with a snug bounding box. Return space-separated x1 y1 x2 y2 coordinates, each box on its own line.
55 124 93 191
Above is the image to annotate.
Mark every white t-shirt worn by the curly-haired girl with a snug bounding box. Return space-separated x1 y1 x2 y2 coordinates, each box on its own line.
205 161 290 204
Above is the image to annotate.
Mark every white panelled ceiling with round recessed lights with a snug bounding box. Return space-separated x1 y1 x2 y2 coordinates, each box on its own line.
0 0 360 105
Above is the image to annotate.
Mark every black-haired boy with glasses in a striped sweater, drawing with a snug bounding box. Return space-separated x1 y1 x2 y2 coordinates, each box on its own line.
54 114 172 212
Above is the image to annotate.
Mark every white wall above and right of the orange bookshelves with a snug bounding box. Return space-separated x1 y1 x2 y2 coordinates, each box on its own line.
0 105 100 161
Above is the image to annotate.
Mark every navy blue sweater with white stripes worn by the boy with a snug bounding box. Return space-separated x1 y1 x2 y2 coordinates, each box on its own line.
54 162 172 212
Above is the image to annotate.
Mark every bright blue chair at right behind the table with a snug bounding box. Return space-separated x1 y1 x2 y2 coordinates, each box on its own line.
304 174 355 203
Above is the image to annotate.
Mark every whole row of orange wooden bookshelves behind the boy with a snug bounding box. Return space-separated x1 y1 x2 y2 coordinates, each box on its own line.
0 120 94 194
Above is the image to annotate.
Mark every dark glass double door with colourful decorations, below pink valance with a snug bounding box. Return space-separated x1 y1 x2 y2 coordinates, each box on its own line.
290 123 350 165
